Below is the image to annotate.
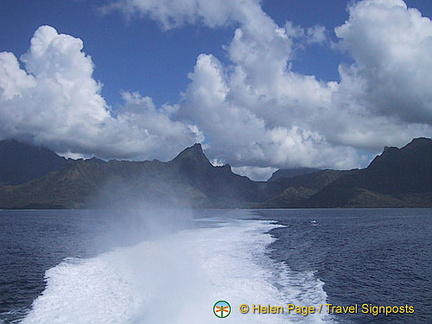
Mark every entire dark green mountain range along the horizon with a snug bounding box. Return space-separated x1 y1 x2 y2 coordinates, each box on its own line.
0 138 432 208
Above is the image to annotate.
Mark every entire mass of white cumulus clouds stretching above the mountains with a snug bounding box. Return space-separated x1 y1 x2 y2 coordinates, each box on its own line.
0 0 432 179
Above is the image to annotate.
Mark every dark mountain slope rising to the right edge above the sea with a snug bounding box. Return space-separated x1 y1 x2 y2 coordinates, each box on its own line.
303 138 432 207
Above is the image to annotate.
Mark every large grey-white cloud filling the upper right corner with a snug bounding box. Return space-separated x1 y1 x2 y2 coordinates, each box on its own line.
335 0 432 125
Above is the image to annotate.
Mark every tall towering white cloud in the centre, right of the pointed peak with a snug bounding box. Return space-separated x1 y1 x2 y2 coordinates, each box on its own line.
161 0 364 172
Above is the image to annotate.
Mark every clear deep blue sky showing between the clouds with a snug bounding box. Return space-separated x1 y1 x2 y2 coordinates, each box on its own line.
0 0 346 106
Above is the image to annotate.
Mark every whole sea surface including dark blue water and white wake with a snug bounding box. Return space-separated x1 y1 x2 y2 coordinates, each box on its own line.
0 206 432 324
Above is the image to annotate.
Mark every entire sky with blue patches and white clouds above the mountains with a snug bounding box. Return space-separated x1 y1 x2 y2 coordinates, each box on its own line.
0 0 432 180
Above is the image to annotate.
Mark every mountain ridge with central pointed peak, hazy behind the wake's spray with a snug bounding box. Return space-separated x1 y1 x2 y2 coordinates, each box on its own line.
0 144 262 208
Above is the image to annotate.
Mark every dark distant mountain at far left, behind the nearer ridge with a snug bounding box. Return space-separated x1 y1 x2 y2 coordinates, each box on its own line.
0 140 66 185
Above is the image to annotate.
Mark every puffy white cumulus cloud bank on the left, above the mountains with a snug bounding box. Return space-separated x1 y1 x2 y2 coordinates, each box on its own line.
0 26 202 159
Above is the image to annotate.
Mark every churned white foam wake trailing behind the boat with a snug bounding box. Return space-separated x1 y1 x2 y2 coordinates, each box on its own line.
22 214 326 324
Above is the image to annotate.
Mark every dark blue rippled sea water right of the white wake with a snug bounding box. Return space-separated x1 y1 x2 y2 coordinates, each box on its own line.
260 209 432 323
